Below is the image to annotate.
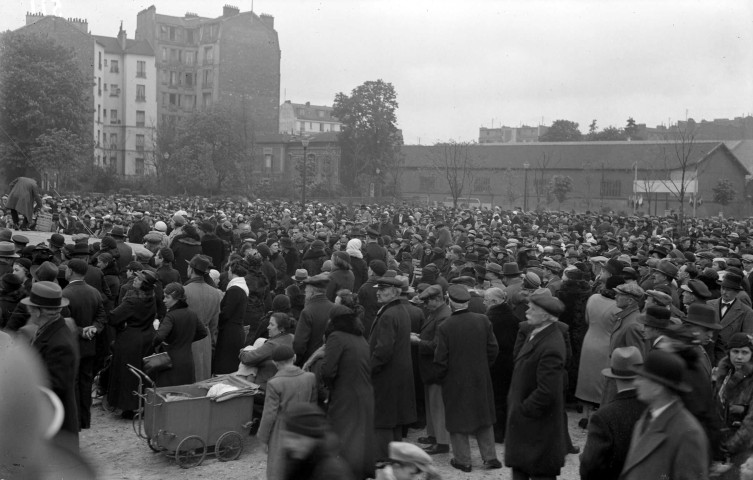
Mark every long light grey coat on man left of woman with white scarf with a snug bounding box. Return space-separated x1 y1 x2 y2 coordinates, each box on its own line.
185 278 222 382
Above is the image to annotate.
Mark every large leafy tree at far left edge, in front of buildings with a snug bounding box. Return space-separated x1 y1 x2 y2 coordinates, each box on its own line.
0 32 91 177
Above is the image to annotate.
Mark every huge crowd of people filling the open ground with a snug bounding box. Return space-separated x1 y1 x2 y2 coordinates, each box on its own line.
0 178 753 480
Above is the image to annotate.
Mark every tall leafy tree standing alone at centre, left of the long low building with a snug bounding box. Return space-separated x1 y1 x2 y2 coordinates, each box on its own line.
332 79 403 194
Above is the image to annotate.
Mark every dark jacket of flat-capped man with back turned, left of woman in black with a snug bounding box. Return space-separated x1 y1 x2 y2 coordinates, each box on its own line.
63 281 107 358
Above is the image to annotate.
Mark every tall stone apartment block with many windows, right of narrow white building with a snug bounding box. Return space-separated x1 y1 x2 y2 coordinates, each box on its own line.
136 5 280 133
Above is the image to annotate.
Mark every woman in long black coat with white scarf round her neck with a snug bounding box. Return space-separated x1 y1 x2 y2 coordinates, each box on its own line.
212 260 248 375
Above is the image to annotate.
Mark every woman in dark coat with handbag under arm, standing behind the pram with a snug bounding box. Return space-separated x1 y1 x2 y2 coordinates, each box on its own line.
152 283 209 387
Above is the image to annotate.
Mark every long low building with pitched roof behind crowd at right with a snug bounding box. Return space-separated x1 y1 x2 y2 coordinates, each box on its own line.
399 141 753 216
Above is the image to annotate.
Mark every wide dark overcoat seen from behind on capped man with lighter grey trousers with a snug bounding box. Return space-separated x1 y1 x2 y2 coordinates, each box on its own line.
434 310 499 433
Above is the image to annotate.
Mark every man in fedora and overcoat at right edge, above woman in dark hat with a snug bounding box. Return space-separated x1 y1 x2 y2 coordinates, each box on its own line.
708 272 753 366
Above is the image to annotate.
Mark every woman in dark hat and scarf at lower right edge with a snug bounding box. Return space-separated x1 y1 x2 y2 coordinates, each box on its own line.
713 333 753 480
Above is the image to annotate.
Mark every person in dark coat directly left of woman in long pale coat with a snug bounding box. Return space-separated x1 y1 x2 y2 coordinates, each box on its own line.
557 279 591 401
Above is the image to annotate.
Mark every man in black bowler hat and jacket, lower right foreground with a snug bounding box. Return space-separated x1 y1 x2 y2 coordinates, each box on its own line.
619 350 709 480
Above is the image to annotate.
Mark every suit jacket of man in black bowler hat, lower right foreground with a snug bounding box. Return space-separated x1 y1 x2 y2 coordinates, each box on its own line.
619 399 709 480
